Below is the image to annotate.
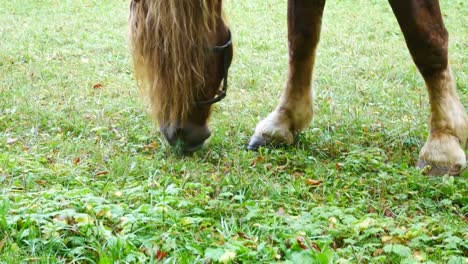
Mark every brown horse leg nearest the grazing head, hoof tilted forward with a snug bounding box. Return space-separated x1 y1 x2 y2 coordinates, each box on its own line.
248 0 325 149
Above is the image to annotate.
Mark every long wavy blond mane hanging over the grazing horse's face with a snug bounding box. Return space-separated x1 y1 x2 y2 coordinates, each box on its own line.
129 0 220 125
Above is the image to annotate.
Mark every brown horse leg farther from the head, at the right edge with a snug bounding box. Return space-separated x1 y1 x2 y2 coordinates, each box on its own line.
389 0 468 175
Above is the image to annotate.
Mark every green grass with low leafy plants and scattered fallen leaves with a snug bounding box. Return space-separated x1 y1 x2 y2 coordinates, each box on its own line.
0 0 468 263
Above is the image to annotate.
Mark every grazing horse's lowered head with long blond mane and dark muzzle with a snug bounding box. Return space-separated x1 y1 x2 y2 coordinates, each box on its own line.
129 0 232 152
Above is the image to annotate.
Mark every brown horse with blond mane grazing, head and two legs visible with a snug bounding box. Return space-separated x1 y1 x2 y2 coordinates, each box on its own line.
130 0 468 175
